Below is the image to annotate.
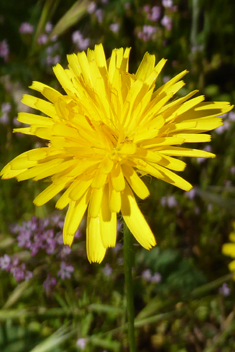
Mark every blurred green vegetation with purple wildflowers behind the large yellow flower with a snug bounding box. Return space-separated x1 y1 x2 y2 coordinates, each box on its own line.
0 0 235 352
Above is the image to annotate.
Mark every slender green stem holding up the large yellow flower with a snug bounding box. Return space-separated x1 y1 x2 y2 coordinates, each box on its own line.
123 223 136 352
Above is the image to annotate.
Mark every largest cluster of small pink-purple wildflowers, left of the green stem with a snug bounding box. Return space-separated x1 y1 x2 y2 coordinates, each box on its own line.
0 215 77 290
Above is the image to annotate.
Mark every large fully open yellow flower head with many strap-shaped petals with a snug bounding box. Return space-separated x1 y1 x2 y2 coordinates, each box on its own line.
1 44 232 262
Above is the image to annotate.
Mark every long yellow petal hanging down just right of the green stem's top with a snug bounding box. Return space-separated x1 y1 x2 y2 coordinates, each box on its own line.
121 185 156 249
